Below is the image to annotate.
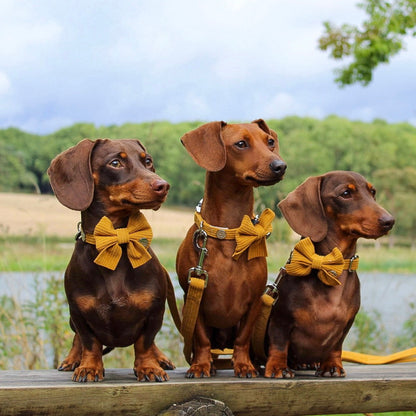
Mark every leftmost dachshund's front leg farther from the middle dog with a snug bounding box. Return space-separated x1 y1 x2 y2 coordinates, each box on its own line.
72 339 104 382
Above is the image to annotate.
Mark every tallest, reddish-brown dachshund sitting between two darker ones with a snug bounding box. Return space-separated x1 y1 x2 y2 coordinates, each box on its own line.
176 120 286 378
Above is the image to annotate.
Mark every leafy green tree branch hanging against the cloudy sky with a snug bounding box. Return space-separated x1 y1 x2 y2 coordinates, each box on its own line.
319 0 416 87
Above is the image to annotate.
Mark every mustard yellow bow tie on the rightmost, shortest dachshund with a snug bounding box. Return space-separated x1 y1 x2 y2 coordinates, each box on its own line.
285 237 358 286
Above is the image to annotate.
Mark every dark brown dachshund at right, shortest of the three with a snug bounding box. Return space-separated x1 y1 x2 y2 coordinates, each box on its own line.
265 171 394 378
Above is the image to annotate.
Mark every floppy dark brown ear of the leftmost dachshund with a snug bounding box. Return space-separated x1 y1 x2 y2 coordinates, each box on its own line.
48 139 95 211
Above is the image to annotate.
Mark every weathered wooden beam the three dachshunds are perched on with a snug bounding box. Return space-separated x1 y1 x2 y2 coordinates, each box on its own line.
0 363 416 416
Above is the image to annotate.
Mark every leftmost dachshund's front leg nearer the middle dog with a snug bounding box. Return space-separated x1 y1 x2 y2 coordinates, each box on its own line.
133 335 169 381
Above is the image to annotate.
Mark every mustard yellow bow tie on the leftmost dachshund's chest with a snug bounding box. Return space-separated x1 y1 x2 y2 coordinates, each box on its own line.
85 213 153 270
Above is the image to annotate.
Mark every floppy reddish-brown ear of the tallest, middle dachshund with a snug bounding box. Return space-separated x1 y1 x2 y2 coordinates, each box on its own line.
181 121 227 172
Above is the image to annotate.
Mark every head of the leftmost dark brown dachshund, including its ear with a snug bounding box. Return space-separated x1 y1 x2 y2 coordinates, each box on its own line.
48 139 169 215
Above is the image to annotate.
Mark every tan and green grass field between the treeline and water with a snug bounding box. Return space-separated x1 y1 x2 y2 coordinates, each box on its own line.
0 193 416 274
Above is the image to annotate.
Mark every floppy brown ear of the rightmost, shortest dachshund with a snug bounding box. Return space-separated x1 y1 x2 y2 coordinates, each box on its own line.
278 176 328 242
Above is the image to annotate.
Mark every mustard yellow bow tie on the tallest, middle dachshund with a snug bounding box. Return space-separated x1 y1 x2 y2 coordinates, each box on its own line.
232 208 274 260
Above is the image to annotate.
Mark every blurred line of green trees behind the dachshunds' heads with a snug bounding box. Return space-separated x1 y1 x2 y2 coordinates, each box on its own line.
0 116 416 241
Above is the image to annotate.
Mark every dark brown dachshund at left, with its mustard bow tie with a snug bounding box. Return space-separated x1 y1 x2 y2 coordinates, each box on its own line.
48 139 174 381
